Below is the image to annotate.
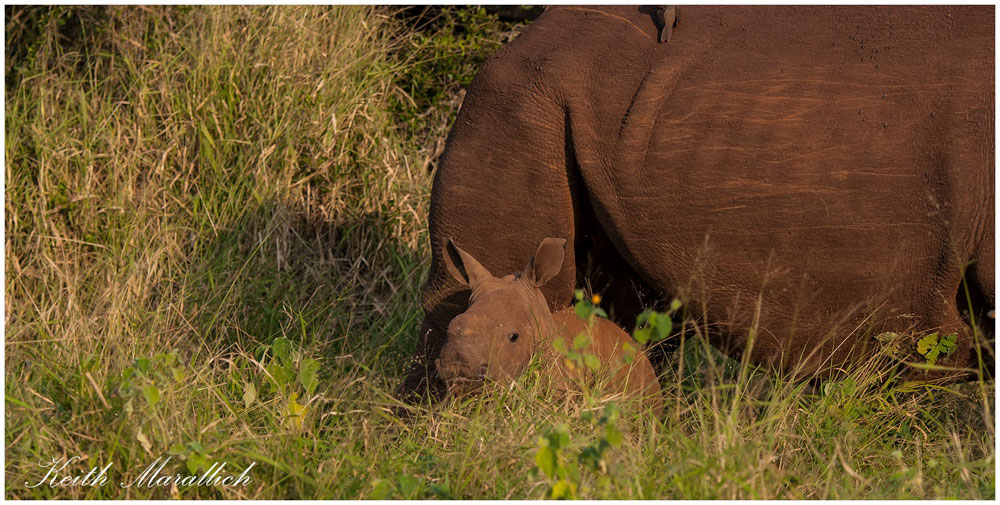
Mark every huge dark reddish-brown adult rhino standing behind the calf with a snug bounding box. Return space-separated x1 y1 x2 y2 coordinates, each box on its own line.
399 6 994 400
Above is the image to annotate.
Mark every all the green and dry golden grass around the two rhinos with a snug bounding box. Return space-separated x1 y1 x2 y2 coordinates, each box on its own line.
4 7 995 499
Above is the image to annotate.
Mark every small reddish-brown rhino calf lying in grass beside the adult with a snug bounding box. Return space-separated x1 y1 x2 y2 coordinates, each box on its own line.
434 238 662 414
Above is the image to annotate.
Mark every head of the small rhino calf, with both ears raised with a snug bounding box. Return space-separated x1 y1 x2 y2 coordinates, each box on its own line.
434 238 566 394
